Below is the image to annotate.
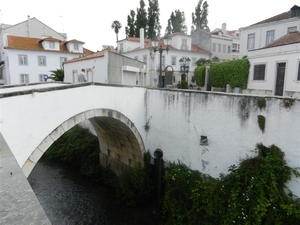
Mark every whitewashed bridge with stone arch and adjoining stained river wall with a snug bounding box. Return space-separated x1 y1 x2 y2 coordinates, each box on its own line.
0 83 300 224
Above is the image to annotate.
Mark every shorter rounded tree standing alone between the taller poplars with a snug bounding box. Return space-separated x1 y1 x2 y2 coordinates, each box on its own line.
165 9 187 35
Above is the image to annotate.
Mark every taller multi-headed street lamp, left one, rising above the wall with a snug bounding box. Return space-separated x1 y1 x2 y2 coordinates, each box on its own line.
152 35 172 88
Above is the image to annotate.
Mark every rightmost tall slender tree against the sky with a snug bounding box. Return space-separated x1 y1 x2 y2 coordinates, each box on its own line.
191 0 209 34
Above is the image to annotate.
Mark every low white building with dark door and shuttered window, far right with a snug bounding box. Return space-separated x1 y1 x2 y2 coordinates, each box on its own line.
247 31 300 98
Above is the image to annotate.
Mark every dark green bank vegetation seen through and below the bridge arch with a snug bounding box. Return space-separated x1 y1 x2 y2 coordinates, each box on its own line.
44 125 153 206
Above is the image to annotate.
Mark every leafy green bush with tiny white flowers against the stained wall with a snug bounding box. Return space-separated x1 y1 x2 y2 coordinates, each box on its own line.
163 144 300 225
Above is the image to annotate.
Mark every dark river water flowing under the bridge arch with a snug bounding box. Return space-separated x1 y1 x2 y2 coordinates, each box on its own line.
28 158 159 225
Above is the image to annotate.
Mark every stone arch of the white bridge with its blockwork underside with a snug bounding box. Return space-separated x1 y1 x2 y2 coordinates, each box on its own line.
22 108 145 177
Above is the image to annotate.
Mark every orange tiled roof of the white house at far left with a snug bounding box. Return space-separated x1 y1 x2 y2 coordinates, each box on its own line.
5 35 92 54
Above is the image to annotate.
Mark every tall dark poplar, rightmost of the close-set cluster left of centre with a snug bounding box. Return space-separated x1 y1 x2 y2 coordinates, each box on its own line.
146 0 161 39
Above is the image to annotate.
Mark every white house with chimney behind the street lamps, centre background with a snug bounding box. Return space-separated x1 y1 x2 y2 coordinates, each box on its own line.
118 29 210 87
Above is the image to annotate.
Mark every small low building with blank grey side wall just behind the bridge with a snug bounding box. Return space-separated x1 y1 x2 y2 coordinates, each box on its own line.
64 49 147 86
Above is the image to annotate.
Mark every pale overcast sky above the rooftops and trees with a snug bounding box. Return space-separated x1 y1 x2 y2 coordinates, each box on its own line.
0 0 300 51
